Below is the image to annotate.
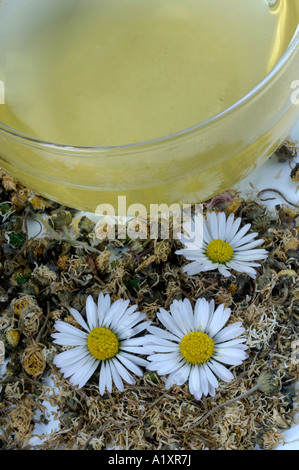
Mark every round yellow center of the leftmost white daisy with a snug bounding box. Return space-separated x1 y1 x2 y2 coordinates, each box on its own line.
87 328 119 361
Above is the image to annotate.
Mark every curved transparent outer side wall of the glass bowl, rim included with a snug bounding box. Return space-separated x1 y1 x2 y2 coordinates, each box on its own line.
0 16 299 213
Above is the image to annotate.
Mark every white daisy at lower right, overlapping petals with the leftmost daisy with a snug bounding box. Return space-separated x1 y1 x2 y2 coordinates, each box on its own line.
146 299 248 400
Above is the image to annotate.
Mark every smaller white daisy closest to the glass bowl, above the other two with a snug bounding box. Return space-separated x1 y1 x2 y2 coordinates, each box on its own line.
176 212 268 279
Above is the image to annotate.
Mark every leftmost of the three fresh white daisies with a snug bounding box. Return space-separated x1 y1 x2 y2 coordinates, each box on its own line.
52 293 150 395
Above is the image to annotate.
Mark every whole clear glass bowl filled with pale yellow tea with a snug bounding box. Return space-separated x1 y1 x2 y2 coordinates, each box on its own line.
0 0 299 212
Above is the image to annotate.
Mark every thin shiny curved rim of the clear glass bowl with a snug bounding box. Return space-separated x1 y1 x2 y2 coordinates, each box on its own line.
0 24 299 152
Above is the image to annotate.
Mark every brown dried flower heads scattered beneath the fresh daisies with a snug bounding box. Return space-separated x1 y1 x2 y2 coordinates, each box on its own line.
0 143 299 450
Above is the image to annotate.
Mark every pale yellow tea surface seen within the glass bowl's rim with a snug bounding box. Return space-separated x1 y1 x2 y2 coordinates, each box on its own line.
0 0 298 146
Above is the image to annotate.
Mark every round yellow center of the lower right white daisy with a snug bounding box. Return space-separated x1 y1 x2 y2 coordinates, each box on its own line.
180 331 215 364
